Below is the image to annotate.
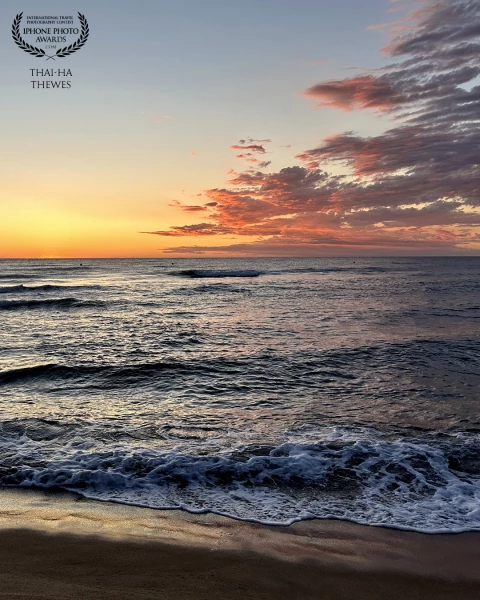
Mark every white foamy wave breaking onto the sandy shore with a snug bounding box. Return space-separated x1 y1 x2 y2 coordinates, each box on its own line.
0 422 480 533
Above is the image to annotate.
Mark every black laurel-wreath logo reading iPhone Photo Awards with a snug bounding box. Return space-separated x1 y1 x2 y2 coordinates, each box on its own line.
12 12 90 60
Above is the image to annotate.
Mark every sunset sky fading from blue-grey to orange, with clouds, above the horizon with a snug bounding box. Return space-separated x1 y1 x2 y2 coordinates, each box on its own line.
0 0 480 258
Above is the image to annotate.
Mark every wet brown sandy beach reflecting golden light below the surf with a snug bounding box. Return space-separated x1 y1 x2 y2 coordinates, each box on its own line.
0 490 480 600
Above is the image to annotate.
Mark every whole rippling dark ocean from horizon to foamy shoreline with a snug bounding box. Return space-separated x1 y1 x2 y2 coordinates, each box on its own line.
0 257 480 533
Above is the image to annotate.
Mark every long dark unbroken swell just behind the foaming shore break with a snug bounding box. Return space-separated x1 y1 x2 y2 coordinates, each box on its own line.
0 338 480 396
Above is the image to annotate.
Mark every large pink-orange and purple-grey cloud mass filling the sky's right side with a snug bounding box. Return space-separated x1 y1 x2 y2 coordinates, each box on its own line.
145 0 480 255
